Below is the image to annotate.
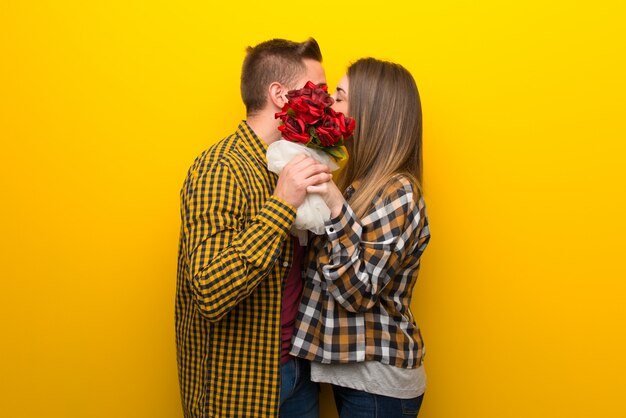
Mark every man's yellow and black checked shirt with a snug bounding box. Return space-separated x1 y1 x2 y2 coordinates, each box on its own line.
176 122 296 418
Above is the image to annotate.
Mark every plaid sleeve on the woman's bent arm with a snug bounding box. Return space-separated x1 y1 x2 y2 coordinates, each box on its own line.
310 177 423 312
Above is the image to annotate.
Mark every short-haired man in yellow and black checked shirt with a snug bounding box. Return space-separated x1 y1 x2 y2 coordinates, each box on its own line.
176 39 330 418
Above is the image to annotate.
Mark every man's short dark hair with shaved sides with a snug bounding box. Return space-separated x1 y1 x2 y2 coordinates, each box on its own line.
241 38 322 115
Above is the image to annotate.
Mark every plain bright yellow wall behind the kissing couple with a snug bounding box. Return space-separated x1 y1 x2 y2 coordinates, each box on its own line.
0 0 626 418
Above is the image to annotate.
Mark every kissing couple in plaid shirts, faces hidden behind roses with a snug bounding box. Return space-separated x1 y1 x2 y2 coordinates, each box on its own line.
176 39 430 418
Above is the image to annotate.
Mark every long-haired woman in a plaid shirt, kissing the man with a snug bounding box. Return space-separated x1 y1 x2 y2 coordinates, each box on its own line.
291 58 430 418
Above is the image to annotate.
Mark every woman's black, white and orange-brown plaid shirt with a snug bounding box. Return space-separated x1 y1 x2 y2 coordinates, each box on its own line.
291 176 430 368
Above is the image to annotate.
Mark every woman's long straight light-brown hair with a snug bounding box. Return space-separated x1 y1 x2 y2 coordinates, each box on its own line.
338 58 422 217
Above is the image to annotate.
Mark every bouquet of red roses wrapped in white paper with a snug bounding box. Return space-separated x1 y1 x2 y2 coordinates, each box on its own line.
267 81 355 244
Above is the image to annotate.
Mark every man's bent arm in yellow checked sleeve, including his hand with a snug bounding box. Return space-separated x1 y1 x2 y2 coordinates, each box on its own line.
182 158 330 321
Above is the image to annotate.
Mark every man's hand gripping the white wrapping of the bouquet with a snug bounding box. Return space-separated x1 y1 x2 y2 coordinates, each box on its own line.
274 155 332 208
